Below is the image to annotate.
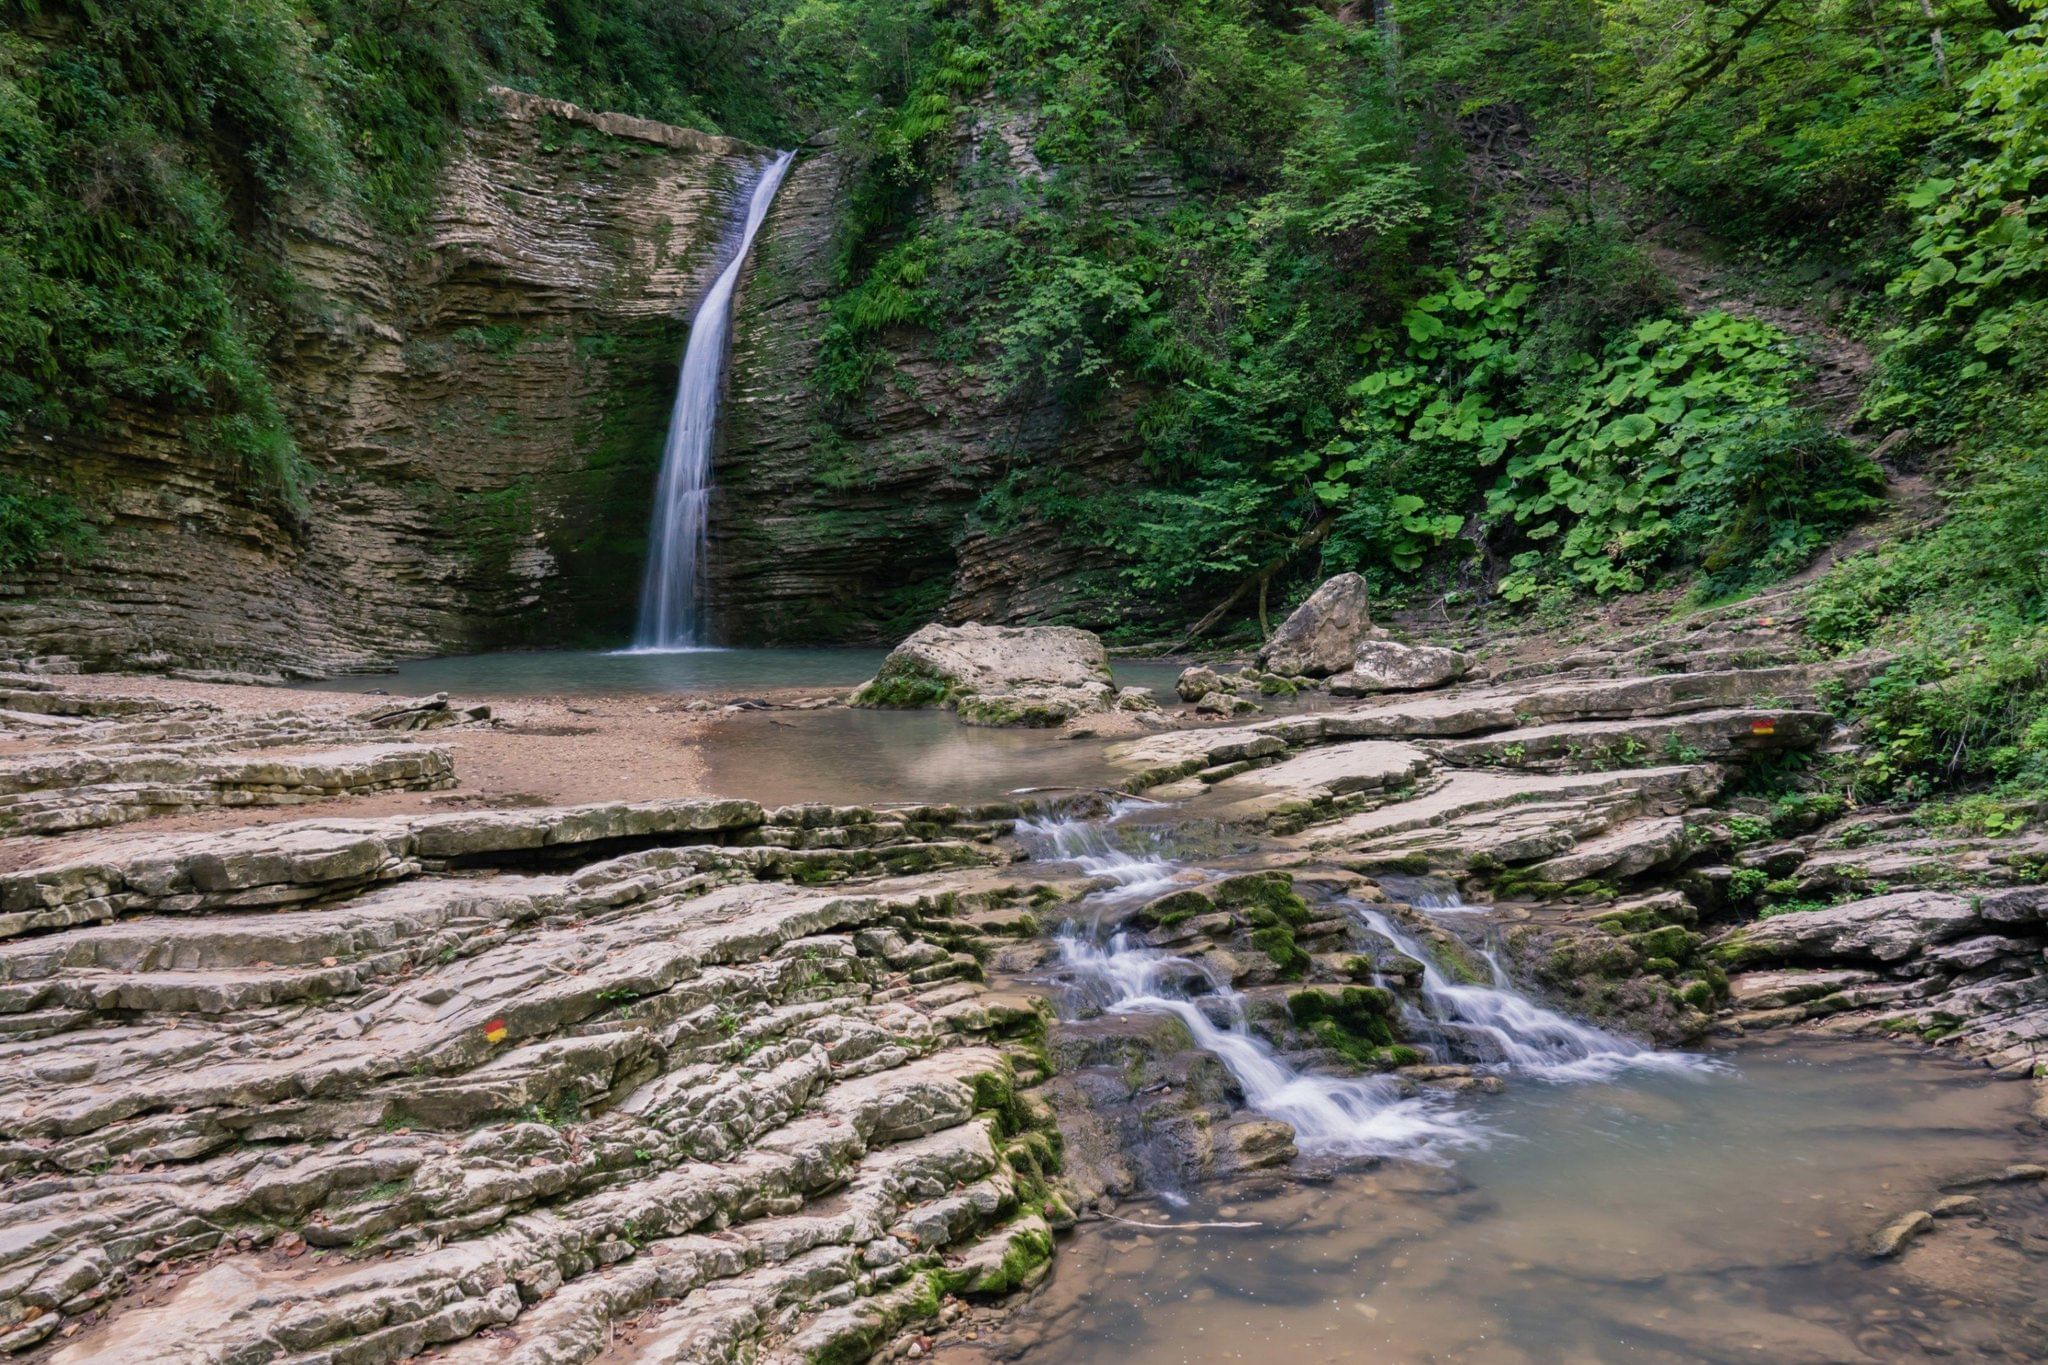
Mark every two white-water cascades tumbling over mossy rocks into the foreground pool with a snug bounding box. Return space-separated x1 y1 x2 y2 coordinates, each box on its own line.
1018 812 1708 1160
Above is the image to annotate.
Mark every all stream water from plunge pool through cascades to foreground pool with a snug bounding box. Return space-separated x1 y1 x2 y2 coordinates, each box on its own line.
307 651 2048 1365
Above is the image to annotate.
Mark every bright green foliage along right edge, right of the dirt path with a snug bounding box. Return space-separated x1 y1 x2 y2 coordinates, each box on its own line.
1808 23 2048 798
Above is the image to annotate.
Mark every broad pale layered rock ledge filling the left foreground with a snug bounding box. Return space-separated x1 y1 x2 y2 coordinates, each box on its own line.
0 800 1071 1365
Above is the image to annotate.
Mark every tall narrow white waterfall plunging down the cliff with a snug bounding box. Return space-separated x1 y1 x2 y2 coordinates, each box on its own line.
633 151 795 651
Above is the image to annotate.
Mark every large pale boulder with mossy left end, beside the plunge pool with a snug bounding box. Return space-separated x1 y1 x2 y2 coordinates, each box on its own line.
850 624 1116 726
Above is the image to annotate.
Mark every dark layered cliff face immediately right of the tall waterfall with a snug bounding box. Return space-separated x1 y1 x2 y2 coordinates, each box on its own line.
711 113 1171 643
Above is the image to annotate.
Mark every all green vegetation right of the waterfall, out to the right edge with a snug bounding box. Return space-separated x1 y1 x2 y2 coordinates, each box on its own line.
794 0 2048 810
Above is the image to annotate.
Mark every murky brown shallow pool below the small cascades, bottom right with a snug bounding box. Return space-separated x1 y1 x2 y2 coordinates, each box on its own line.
958 1042 2048 1365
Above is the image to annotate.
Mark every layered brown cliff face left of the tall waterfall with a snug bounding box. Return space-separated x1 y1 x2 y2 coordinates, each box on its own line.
0 92 766 669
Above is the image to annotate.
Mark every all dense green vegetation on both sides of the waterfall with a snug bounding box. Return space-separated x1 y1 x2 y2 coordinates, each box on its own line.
0 0 2048 810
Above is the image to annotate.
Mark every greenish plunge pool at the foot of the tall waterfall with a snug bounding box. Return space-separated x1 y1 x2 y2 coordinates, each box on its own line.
303 649 1184 698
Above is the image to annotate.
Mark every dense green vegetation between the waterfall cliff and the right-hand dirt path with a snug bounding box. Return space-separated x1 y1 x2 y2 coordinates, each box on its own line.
802 0 2009 618
